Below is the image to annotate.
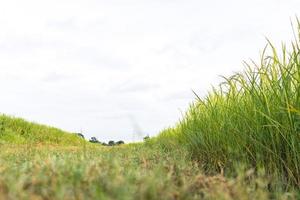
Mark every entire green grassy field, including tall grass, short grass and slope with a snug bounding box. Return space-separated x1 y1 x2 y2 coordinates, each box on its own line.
0 23 300 199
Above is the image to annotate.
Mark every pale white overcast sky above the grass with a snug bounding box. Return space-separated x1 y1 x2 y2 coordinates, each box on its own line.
0 0 300 142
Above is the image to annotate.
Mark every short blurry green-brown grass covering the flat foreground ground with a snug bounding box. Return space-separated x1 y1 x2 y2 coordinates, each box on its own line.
0 144 296 200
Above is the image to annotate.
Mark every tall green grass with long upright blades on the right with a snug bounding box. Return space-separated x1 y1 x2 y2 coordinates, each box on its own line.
159 21 300 186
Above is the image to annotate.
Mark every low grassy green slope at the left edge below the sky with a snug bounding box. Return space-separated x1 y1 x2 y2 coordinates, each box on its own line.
0 115 85 145
